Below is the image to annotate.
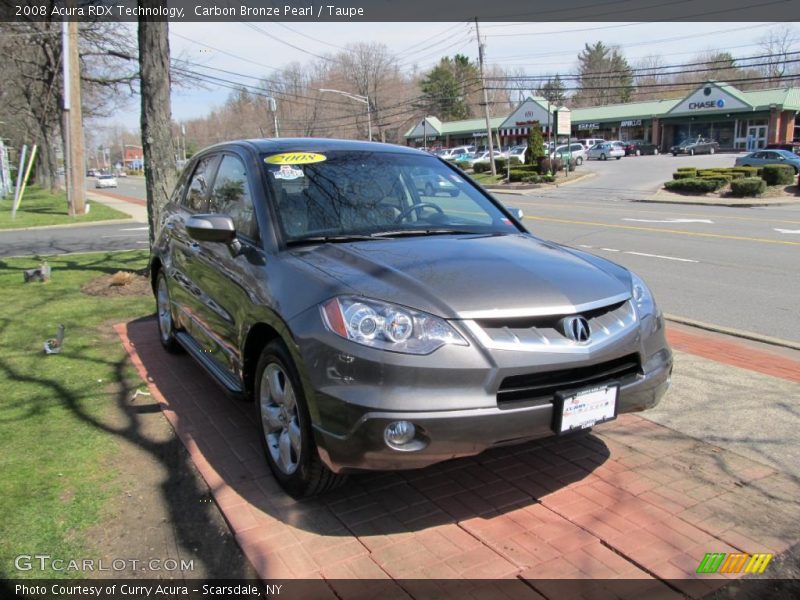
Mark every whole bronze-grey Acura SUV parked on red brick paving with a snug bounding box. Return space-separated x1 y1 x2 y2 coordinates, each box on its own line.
151 139 672 496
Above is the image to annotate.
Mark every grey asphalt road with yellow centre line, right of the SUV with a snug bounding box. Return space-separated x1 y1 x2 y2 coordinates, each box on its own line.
498 154 800 342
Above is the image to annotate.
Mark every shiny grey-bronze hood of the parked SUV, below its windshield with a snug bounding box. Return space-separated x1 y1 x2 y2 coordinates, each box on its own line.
293 234 630 318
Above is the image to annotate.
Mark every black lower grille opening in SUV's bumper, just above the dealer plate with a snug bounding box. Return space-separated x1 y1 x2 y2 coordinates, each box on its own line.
497 354 642 405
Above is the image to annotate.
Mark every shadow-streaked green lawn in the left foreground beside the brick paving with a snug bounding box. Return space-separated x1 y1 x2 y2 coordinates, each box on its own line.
0 251 153 578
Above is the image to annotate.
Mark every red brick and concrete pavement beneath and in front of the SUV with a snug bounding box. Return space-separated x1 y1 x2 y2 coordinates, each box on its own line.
116 319 800 598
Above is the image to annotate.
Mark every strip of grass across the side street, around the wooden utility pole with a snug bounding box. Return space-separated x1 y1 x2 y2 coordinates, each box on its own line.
0 185 130 229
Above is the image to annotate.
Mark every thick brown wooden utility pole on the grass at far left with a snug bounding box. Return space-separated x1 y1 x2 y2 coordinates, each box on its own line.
61 21 86 217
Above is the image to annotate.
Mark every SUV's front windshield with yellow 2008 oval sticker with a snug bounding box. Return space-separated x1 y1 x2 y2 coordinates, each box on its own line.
262 150 519 242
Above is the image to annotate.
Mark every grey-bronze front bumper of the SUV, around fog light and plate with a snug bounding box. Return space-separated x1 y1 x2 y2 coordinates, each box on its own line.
293 310 672 473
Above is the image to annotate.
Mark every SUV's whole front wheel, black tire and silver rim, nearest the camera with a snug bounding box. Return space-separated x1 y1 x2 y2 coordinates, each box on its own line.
253 341 346 498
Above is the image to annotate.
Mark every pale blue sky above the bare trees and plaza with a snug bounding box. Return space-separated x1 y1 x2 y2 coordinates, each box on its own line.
99 21 798 129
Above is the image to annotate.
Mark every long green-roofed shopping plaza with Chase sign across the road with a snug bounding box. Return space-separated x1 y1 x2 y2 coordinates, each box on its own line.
405 81 800 151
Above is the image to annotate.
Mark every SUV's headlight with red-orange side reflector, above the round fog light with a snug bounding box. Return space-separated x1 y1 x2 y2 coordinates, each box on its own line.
320 296 468 354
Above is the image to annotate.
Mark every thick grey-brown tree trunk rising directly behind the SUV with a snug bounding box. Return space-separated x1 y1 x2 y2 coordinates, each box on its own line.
139 5 176 247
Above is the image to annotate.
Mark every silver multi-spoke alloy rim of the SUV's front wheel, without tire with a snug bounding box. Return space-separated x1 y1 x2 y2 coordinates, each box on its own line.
259 363 303 475
